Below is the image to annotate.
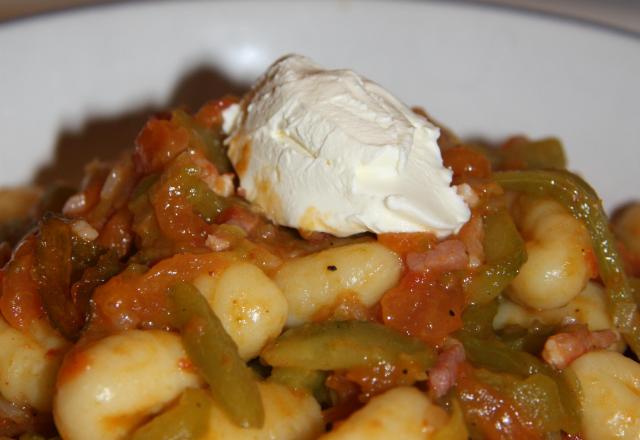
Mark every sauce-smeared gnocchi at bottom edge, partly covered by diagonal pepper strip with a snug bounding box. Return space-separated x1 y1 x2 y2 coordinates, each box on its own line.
203 382 324 440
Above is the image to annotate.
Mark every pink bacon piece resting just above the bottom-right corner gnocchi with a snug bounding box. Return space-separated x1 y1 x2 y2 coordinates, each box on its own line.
542 326 620 369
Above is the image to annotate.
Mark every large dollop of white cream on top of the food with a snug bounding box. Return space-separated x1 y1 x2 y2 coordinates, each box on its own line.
223 55 470 241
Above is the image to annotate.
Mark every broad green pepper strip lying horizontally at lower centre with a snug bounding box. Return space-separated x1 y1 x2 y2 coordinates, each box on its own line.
261 321 435 370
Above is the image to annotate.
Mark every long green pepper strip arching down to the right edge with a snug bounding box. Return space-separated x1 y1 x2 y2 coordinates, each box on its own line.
493 171 640 355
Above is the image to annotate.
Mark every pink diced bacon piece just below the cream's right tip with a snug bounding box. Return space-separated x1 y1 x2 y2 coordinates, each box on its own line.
406 240 469 272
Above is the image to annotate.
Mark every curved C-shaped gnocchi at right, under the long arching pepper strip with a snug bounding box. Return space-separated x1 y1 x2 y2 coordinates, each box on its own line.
508 197 591 310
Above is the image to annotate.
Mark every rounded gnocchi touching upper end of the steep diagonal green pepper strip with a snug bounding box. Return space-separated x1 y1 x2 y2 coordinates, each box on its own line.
193 262 288 360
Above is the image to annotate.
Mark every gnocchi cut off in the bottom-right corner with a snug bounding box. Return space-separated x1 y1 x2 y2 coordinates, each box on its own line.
569 351 640 440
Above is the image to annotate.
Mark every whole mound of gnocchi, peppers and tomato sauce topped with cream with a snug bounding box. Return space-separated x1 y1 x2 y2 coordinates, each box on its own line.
0 56 640 440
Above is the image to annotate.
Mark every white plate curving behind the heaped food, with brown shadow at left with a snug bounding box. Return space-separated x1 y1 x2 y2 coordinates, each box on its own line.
0 1 640 207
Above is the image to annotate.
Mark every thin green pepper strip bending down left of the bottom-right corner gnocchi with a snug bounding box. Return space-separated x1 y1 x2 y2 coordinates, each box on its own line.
456 332 580 433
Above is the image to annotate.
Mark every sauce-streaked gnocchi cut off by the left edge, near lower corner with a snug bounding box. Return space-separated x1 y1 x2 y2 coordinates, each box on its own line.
0 317 67 412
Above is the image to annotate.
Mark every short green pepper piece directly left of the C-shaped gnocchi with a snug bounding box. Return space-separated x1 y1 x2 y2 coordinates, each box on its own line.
465 211 527 304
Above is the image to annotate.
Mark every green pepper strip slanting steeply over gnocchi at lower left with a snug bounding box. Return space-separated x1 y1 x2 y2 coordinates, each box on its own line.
170 283 264 428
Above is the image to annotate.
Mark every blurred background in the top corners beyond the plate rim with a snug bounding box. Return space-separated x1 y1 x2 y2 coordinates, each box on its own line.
0 0 640 33
